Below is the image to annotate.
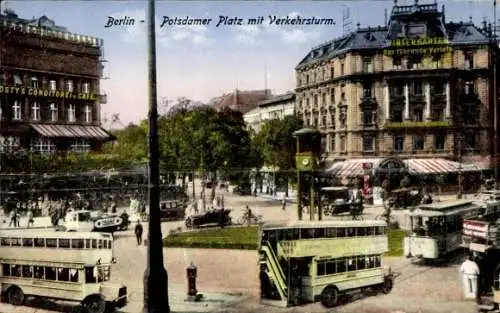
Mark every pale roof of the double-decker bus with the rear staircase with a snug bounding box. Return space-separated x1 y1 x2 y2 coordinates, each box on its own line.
262 217 387 230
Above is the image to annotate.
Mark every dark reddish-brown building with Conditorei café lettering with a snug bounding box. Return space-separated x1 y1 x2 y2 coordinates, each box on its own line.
0 11 112 154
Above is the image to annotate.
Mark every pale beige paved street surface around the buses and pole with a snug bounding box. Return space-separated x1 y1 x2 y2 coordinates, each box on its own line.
0 182 484 313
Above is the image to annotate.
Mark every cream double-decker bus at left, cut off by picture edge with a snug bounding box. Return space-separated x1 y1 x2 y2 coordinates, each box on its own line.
0 231 127 313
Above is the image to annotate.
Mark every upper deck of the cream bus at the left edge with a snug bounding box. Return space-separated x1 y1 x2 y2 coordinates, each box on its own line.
0 230 114 264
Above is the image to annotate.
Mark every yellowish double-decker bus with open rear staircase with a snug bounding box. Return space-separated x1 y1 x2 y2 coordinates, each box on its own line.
259 221 393 307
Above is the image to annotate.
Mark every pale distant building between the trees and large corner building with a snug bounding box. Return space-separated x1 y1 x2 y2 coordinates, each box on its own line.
243 92 295 132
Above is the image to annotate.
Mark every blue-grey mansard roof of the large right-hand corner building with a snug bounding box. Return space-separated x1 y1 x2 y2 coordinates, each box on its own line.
296 3 490 69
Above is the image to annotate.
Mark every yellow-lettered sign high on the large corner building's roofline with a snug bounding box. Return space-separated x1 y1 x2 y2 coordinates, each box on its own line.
384 37 453 56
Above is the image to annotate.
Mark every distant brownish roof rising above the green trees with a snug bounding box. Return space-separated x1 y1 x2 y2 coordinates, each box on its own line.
208 89 271 114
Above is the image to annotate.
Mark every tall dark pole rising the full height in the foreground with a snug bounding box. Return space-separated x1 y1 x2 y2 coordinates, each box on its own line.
143 0 170 313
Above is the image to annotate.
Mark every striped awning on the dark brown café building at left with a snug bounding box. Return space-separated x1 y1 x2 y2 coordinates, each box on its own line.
31 124 112 139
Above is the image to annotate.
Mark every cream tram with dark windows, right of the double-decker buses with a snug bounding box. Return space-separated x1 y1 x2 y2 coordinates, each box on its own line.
403 200 484 260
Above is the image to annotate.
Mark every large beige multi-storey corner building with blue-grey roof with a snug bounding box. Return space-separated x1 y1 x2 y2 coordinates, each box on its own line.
296 1 498 176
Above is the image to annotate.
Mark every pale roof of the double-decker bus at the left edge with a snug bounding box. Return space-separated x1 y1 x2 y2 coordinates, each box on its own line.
0 229 113 239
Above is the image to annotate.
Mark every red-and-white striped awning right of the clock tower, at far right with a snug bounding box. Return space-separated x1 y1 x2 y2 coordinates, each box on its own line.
403 159 483 174
